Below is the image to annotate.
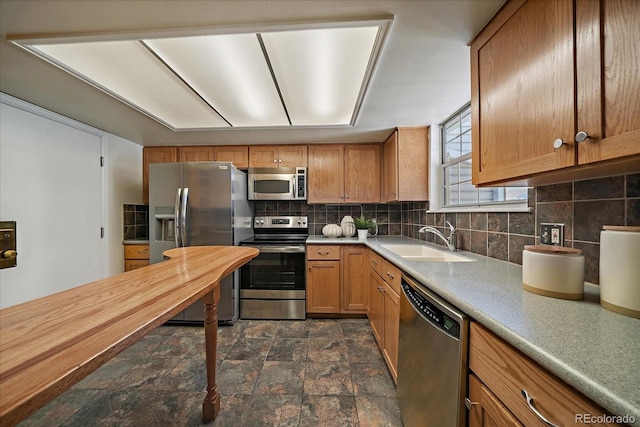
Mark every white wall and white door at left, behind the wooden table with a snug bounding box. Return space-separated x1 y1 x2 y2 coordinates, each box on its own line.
0 94 142 307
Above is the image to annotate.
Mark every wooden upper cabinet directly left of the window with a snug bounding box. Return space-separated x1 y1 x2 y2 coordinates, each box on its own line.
382 126 430 202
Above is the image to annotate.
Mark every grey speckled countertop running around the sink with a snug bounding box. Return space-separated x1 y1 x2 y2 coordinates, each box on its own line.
307 236 640 426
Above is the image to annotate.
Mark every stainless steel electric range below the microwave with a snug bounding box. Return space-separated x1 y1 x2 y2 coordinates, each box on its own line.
240 216 309 319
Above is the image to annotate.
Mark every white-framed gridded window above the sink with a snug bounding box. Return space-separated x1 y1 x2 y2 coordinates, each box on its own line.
440 103 527 207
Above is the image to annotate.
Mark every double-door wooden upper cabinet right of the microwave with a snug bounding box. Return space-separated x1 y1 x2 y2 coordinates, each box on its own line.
307 144 381 203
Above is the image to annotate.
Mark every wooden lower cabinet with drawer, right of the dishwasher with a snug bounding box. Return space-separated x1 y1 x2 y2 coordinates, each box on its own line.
469 322 614 427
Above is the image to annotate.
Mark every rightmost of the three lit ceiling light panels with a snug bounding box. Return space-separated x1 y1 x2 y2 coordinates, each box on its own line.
262 27 378 126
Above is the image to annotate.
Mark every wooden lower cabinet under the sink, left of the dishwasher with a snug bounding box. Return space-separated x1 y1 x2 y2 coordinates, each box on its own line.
367 251 401 382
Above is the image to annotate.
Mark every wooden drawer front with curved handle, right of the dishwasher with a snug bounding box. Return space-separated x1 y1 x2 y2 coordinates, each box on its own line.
469 322 610 426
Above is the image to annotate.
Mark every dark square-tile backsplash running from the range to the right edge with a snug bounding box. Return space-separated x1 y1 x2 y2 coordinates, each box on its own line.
264 174 640 284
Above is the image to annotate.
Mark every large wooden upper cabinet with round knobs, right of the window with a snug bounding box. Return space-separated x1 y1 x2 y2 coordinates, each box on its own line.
471 0 640 184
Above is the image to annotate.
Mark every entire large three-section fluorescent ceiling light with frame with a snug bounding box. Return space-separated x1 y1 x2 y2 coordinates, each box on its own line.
22 21 388 130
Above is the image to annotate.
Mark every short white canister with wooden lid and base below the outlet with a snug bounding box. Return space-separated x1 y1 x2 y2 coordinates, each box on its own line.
522 245 584 300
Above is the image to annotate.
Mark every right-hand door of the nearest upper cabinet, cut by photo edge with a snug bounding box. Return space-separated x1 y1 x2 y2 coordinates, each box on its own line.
576 0 640 164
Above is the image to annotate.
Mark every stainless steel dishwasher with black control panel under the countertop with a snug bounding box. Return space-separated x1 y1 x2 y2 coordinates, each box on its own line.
396 274 469 427
